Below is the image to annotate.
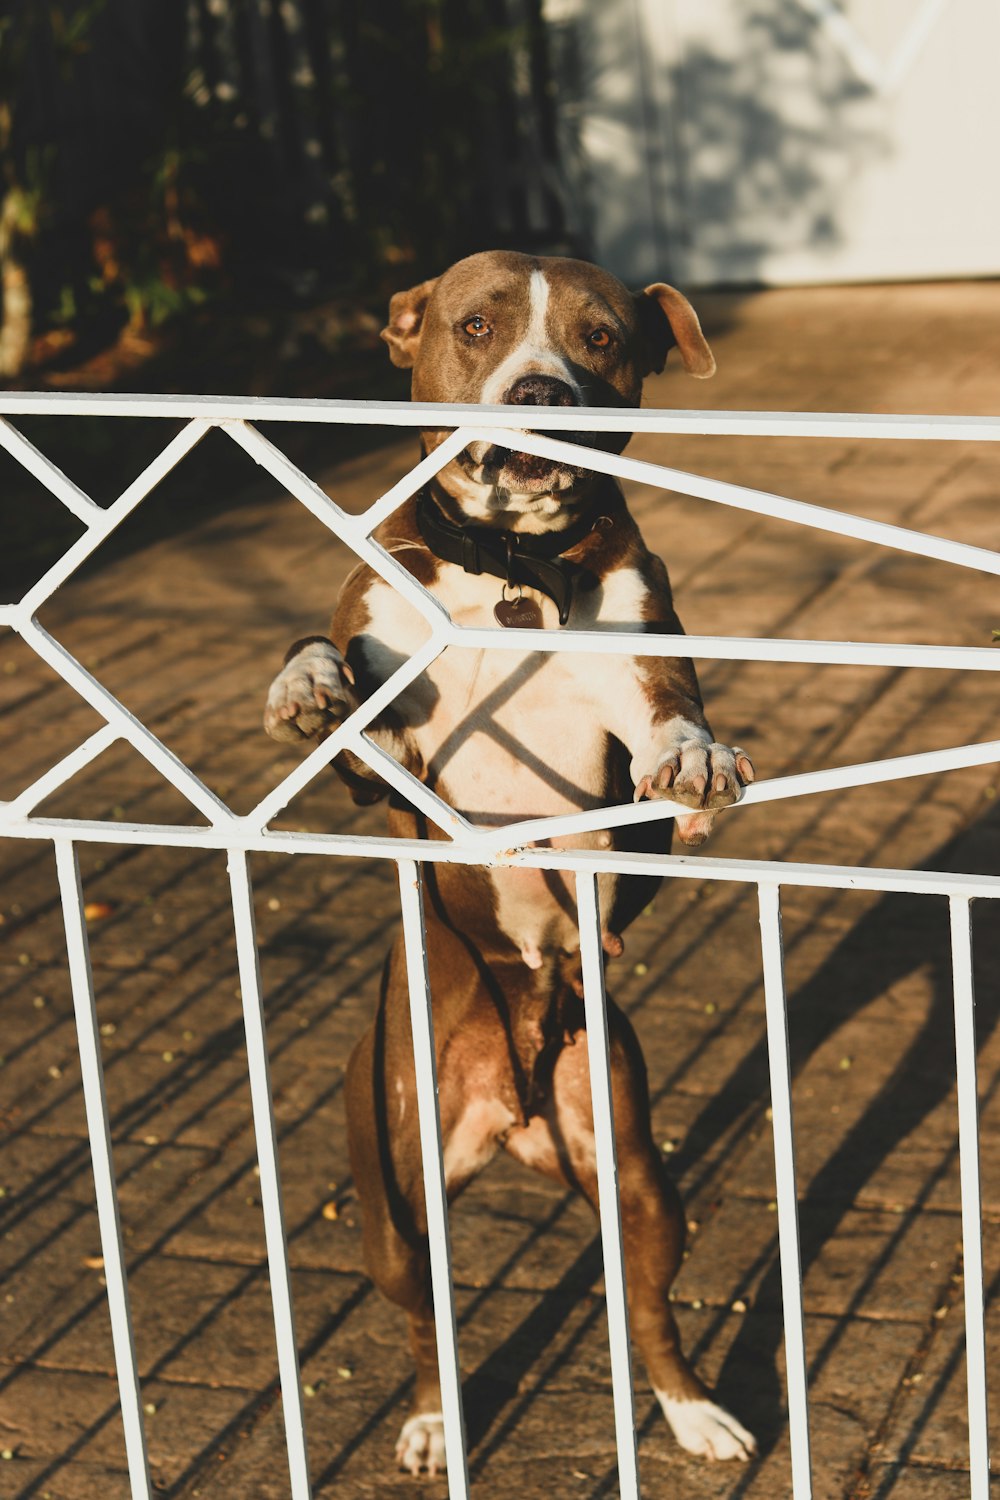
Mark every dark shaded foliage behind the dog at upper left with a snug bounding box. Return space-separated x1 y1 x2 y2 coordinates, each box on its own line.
0 0 562 375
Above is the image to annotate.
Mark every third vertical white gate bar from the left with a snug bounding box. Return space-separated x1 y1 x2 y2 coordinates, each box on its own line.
399 860 469 1500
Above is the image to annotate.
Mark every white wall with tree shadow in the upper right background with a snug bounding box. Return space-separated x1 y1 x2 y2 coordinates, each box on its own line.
546 0 1000 285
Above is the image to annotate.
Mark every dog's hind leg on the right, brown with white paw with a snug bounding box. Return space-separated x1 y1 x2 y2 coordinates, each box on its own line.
505 1001 757 1460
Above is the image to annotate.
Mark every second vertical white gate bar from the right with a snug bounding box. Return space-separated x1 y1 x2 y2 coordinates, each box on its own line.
757 884 813 1500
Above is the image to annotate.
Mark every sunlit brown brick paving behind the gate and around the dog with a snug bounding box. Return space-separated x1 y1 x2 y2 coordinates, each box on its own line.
0 285 1000 1500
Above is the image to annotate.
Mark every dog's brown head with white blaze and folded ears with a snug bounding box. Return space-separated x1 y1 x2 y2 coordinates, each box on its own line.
382 251 715 525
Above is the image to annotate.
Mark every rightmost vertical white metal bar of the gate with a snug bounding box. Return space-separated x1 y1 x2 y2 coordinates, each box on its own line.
949 896 990 1500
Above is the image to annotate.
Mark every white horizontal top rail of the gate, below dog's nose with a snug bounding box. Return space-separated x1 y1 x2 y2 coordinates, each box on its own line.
0 390 1000 443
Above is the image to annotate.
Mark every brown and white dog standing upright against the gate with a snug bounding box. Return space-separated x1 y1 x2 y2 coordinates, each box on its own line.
264 252 756 1475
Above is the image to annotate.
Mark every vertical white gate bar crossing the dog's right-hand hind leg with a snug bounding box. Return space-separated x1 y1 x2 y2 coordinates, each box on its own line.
576 873 639 1500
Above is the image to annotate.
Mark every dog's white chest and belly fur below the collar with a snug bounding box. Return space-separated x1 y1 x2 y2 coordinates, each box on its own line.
364 569 639 968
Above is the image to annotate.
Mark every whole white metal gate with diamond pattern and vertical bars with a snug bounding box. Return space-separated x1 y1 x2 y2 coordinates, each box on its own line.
0 393 1000 1500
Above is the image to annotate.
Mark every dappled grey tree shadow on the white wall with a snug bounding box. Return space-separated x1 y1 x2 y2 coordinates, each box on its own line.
550 0 889 285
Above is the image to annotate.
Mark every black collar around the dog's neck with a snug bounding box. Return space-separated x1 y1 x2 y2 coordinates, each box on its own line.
417 489 603 626
